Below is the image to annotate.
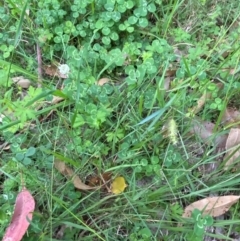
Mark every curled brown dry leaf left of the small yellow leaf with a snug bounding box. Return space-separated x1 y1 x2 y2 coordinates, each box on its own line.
54 160 95 190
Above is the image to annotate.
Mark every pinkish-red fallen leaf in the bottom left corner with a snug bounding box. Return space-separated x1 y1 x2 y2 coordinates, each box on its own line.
2 188 35 241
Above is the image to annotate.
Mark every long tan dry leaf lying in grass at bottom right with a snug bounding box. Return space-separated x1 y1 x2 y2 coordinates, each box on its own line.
182 195 240 218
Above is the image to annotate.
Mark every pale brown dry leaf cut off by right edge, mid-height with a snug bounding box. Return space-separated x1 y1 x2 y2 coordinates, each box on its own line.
224 128 240 170
